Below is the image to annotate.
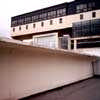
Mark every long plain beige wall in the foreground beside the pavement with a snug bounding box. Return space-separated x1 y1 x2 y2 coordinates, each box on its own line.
0 43 93 100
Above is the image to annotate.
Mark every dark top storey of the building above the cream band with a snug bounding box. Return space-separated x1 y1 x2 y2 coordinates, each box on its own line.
11 0 100 27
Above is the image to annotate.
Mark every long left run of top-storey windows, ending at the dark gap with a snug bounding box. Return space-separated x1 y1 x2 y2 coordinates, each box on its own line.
11 8 66 27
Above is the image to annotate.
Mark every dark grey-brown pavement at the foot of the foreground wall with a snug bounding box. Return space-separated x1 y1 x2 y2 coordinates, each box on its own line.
20 77 100 100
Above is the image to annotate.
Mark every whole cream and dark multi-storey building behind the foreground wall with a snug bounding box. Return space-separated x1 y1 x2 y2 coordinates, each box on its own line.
11 0 100 49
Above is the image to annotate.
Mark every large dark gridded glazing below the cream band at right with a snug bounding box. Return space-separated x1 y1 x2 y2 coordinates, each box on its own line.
73 19 100 37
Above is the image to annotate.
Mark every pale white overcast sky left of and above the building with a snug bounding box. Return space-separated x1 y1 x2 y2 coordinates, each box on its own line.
0 0 72 37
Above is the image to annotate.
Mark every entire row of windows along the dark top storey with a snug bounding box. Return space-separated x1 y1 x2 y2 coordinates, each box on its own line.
11 2 96 27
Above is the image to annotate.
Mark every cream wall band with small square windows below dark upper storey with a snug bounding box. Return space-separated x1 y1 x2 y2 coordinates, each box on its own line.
11 10 100 36
